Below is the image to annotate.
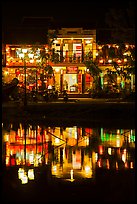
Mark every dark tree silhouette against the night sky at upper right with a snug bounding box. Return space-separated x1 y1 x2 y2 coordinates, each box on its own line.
106 1 135 43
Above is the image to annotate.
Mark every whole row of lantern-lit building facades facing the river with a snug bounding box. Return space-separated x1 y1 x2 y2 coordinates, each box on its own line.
2 28 135 94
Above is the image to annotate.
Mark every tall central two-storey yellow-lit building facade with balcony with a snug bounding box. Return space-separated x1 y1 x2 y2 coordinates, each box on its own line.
52 28 96 94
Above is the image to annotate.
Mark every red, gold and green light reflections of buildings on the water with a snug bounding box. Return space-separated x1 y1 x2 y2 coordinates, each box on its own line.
2 123 135 184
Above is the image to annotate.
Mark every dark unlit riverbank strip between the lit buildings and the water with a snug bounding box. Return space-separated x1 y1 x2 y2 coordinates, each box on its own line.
2 99 135 128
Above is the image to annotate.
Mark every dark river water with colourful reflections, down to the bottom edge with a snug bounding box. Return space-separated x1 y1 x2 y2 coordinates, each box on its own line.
2 121 135 202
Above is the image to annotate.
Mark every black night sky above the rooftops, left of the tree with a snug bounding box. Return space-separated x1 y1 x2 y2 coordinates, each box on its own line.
2 0 133 27
